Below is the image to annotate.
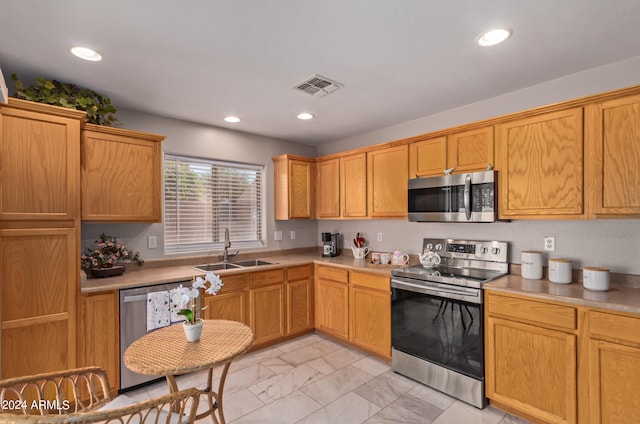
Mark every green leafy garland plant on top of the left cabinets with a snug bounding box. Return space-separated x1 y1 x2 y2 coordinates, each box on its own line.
11 74 117 126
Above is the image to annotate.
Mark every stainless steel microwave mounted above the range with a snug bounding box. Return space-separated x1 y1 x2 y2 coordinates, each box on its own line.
408 171 498 222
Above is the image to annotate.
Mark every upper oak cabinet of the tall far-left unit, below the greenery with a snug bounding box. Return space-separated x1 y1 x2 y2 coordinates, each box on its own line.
0 99 85 220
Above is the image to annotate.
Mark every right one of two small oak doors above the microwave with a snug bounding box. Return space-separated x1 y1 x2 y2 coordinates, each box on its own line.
447 126 495 172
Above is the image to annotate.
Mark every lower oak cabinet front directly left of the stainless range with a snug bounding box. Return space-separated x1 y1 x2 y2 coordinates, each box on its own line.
349 272 391 359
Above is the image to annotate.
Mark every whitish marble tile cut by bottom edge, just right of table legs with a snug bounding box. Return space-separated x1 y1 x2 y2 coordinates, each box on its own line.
233 391 322 424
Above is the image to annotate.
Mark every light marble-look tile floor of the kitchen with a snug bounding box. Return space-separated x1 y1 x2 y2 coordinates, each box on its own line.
126 333 526 424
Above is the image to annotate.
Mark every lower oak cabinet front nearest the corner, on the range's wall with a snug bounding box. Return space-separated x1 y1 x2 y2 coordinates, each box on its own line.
315 265 349 340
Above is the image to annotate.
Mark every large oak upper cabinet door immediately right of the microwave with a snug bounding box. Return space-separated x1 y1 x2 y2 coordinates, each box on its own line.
496 108 585 219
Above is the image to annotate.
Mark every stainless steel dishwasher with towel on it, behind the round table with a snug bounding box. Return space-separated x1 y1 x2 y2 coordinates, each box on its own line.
120 280 192 392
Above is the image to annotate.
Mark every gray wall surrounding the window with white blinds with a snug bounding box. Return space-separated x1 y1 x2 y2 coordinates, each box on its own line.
81 109 318 260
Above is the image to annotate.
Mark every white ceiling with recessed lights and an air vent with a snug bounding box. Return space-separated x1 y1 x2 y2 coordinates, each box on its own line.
0 0 640 145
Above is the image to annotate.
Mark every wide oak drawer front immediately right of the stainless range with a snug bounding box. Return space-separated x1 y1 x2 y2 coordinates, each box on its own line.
487 294 576 330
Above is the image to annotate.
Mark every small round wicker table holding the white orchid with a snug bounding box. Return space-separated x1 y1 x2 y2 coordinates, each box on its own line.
124 320 254 424
